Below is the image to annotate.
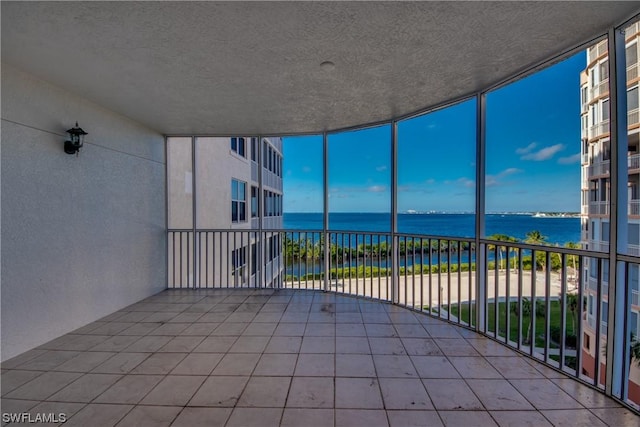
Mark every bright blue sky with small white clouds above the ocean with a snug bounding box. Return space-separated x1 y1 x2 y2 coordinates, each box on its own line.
284 53 585 212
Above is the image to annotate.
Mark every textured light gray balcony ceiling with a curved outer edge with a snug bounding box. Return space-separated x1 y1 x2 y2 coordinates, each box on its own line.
1 1 640 134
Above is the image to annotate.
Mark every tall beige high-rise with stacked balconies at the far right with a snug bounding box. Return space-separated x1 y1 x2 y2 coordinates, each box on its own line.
580 22 640 404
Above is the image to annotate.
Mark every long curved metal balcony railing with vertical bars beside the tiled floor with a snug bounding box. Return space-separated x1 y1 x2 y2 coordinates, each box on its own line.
167 229 637 412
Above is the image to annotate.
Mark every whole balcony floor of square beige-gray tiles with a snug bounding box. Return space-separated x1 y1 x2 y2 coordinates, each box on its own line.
1 289 640 427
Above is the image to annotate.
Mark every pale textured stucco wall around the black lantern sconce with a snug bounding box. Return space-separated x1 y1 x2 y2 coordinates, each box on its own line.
1 64 166 360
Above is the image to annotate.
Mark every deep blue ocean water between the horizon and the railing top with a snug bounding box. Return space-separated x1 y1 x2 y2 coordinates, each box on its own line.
283 213 580 246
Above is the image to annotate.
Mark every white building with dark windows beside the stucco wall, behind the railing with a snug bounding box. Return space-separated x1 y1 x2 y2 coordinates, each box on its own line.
167 136 283 287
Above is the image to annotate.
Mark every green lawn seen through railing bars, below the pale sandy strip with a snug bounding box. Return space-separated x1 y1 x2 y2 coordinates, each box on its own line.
445 300 578 348
